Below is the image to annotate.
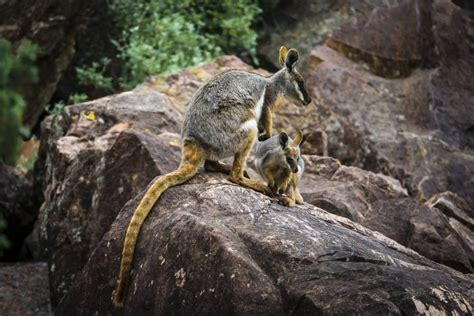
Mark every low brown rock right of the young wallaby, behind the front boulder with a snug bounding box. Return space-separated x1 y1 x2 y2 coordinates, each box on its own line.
300 162 474 273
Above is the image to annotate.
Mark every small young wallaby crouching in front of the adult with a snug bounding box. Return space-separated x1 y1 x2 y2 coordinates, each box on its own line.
255 131 304 207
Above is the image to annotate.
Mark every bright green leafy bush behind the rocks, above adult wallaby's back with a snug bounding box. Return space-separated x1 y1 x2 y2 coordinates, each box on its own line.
76 0 264 91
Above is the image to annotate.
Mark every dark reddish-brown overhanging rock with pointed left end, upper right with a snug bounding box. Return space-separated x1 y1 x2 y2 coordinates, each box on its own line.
327 0 434 78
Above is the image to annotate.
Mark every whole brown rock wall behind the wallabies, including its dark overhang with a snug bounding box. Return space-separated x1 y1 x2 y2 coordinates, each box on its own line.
260 0 474 209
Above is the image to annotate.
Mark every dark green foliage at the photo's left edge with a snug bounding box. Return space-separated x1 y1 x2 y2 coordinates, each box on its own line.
0 38 37 165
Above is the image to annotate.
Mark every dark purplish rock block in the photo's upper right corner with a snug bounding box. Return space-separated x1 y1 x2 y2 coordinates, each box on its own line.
430 0 474 148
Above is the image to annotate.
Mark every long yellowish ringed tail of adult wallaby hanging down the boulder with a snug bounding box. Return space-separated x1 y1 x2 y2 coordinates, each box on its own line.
113 143 204 308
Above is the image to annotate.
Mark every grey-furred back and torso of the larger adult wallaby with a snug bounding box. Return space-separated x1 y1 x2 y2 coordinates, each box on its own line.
182 53 311 161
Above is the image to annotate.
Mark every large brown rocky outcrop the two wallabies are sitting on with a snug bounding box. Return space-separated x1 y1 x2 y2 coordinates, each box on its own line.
34 57 474 315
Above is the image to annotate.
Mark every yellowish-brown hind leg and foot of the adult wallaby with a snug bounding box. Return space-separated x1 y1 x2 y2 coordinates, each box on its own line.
229 130 271 195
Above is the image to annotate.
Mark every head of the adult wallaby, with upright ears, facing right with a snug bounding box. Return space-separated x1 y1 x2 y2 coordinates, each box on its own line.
278 46 311 105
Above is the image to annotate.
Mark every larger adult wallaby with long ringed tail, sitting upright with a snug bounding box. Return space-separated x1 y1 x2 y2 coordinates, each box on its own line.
113 47 311 308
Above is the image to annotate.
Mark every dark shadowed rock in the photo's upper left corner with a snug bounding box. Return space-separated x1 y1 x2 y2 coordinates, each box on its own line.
0 0 94 128
